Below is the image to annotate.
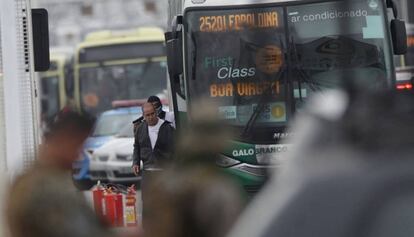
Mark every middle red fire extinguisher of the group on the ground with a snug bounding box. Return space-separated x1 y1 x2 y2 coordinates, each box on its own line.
104 188 124 226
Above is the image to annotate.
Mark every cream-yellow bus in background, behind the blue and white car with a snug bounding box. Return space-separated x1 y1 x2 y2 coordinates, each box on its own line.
74 27 168 115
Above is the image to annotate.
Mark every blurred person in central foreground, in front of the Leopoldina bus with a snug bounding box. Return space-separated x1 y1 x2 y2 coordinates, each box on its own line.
144 99 245 237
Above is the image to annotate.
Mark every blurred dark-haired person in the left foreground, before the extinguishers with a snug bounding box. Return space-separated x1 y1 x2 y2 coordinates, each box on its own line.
7 111 115 237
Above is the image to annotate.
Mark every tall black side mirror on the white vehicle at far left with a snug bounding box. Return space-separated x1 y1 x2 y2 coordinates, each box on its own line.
32 8 50 72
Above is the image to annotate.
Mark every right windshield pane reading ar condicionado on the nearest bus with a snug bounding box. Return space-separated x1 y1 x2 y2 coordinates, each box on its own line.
287 0 392 108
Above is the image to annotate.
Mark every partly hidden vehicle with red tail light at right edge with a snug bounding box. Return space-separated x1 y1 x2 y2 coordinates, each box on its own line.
396 24 414 90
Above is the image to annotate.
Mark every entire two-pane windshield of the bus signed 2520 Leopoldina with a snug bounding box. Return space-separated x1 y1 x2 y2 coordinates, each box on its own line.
184 0 393 142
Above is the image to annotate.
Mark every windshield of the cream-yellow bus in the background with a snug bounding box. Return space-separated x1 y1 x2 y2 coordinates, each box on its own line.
79 59 167 114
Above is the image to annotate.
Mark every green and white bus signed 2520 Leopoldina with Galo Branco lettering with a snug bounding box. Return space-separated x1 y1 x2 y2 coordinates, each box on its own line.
165 0 406 192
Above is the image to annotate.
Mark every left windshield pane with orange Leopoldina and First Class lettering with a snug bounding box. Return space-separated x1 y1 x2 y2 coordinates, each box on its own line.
186 7 289 139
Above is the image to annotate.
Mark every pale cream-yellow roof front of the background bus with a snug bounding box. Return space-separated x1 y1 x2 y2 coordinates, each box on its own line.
78 27 164 48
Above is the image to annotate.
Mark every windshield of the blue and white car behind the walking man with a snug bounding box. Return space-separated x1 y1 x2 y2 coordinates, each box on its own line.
92 113 138 137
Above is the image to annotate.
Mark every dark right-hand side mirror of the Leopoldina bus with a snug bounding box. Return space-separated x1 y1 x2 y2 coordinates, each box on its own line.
391 19 407 55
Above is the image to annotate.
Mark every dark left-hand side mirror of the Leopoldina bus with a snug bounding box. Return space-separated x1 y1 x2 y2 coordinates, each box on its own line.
165 32 183 80
